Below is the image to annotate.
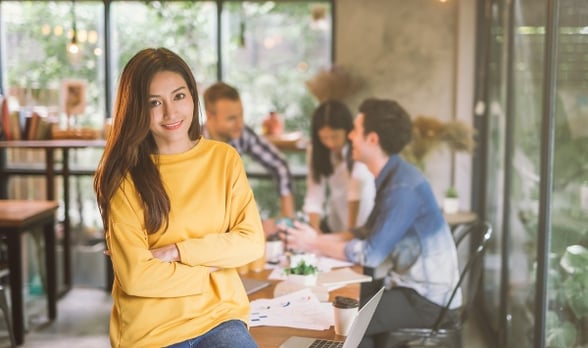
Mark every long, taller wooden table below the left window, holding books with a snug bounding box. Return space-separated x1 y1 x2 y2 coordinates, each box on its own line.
0 139 105 294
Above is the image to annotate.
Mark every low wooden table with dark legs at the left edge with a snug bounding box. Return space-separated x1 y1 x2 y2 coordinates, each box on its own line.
0 200 59 345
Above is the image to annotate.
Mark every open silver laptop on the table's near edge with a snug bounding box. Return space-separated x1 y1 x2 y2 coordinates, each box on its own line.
280 287 384 348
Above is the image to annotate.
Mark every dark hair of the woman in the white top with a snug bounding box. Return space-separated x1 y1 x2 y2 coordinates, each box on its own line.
311 100 353 183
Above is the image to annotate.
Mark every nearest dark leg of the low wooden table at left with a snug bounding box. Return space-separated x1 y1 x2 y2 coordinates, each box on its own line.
6 228 24 345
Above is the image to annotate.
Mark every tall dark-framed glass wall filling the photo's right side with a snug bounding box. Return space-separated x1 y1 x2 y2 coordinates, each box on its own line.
478 0 588 348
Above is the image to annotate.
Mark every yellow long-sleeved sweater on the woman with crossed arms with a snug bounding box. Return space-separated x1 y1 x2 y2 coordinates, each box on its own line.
106 138 264 348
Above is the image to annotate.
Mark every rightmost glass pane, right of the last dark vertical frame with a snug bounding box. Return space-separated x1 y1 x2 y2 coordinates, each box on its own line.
545 0 588 348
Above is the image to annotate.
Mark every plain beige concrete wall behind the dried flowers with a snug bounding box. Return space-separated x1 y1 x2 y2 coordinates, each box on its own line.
335 0 476 210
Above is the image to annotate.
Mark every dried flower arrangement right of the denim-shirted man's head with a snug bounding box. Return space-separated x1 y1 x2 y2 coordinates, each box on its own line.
402 115 476 170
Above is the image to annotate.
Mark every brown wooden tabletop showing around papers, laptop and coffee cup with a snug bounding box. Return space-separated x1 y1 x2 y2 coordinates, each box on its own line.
244 266 361 348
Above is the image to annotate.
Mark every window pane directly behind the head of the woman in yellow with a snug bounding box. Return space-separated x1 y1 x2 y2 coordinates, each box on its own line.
111 1 217 113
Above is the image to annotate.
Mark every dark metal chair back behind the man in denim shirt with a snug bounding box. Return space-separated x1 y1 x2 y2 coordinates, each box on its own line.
432 221 492 333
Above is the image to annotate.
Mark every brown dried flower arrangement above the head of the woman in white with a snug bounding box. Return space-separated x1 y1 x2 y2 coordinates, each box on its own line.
305 66 360 103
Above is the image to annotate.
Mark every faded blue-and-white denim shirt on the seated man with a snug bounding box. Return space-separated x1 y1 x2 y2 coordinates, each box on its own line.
345 155 462 308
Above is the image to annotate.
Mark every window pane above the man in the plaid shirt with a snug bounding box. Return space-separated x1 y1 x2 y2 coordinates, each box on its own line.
221 1 331 131
